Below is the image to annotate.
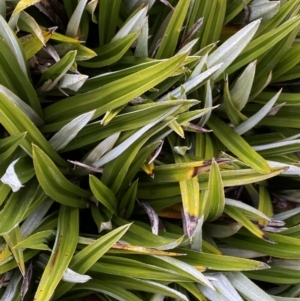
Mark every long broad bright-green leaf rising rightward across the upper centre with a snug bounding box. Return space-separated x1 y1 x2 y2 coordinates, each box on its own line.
44 54 186 129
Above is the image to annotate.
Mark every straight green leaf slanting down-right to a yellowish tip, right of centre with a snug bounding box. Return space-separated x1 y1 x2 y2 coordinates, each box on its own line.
207 115 271 174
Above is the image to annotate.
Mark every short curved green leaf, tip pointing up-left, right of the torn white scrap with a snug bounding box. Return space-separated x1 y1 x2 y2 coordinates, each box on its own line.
32 145 91 208
